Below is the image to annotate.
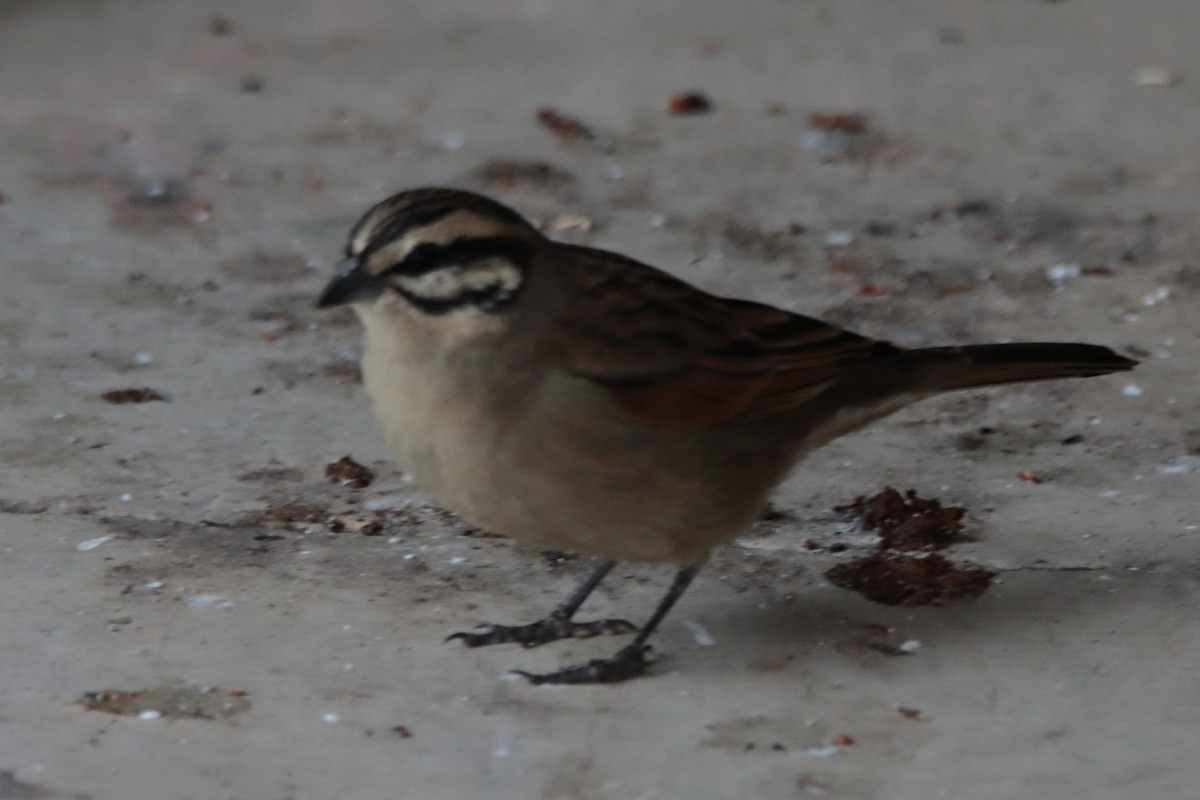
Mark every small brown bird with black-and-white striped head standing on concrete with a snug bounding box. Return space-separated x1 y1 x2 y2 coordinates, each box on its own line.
317 187 1136 684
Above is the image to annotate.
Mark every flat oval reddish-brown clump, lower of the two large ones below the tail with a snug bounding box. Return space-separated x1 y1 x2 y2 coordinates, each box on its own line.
826 553 996 606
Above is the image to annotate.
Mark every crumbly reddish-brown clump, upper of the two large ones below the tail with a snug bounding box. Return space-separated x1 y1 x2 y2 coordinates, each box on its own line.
834 486 967 551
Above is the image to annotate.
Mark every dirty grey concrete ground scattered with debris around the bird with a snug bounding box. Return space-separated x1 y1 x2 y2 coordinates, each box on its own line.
0 0 1200 800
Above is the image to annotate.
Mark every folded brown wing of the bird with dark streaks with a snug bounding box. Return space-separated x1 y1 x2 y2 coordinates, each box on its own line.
560 248 899 427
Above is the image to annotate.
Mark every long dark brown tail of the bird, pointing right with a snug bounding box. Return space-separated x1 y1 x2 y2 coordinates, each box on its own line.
913 342 1138 391
